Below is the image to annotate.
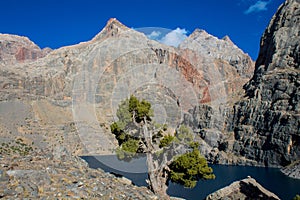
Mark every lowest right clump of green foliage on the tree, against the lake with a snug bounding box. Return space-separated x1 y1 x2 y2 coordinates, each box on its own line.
169 148 215 188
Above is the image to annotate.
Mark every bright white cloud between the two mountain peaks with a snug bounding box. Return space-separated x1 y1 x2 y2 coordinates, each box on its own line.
159 28 187 47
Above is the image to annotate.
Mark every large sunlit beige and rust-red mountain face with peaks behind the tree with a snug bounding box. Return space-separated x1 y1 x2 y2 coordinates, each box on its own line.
0 19 254 160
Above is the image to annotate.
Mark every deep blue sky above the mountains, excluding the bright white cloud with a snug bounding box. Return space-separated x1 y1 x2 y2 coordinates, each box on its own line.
0 0 284 60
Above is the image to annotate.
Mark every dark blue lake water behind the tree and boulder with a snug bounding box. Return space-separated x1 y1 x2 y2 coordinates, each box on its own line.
82 156 300 200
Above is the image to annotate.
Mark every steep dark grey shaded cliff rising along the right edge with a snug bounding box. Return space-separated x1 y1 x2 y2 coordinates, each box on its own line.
233 0 300 166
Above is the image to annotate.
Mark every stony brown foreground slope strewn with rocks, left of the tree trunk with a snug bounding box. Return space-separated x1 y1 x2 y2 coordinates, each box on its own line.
0 147 159 199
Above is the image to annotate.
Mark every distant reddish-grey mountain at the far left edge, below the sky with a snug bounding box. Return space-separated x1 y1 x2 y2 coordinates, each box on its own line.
0 34 51 65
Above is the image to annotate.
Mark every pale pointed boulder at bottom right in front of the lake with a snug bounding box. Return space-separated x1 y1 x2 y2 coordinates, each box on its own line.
205 177 279 200
